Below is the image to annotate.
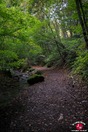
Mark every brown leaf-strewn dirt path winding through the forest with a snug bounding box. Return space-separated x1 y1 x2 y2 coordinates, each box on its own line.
0 67 88 132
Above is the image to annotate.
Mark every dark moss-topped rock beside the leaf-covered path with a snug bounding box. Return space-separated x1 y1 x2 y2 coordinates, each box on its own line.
27 74 44 85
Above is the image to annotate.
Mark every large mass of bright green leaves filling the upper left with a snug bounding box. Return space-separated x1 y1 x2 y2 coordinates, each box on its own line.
0 4 42 69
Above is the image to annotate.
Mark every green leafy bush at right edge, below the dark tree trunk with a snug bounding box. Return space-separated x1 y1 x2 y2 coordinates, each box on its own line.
73 51 88 82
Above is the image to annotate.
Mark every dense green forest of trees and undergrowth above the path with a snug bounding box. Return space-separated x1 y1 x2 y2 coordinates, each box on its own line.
0 0 88 80
